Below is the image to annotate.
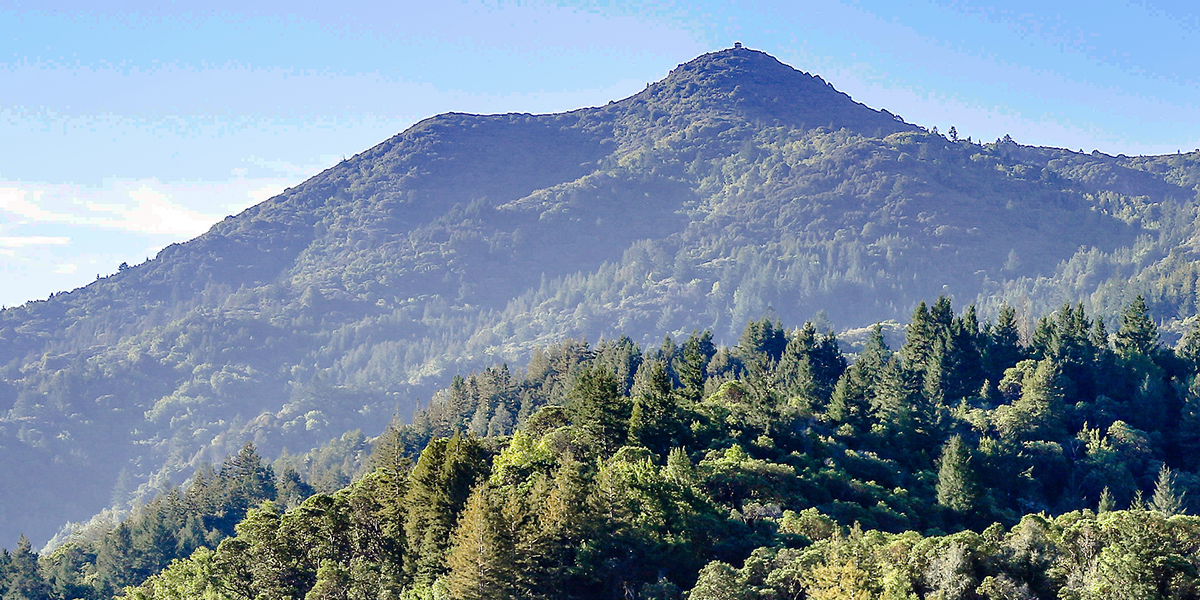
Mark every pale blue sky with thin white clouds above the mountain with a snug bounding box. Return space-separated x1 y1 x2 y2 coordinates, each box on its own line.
0 0 1200 306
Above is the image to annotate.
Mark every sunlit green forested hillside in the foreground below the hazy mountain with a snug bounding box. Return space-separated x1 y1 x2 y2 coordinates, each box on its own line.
7 298 1200 600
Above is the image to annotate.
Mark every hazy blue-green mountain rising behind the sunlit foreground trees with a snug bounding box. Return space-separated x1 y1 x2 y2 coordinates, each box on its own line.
0 48 1200 540
